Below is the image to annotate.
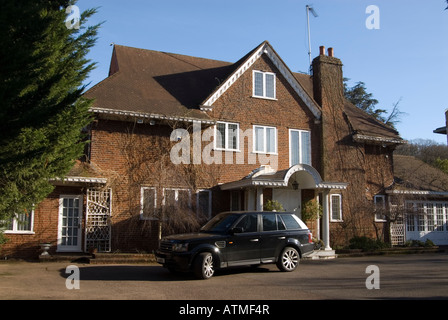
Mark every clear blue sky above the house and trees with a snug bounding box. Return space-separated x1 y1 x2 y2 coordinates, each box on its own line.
77 0 448 143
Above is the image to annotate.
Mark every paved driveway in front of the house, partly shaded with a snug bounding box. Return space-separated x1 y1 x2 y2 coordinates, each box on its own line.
0 253 448 300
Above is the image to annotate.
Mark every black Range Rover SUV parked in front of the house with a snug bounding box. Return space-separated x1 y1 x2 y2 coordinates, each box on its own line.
156 212 314 279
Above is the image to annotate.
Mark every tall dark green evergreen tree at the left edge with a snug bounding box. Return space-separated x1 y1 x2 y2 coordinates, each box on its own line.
0 0 99 227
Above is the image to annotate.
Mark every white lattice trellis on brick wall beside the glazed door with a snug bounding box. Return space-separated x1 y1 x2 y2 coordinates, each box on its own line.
85 189 112 252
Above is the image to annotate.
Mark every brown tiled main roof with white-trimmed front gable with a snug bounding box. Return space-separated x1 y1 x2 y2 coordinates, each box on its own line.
85 41 320 122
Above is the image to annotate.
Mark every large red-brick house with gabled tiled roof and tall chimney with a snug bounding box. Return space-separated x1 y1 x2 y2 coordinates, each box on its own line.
6 41 430 256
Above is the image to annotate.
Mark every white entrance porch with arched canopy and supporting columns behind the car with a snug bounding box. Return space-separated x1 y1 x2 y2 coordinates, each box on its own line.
220 164 347 250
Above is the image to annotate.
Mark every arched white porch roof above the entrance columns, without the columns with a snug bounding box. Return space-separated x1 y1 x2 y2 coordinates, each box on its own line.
221 164 347 190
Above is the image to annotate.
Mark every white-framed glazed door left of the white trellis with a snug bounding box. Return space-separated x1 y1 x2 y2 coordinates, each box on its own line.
57 195 83 252
